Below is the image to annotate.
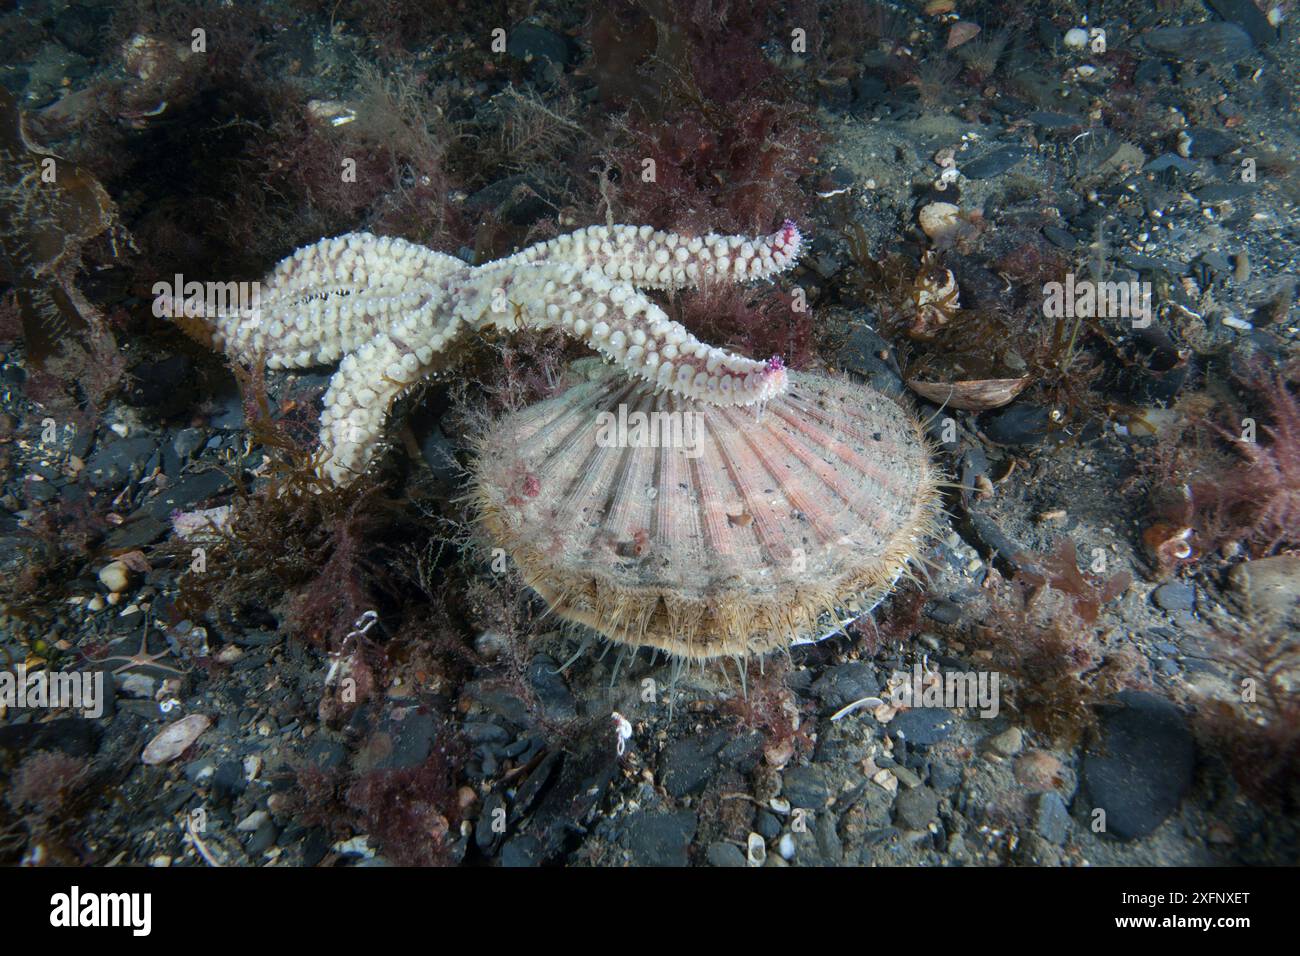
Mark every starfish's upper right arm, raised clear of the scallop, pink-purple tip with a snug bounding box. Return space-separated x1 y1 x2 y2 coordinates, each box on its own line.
484 220 803 289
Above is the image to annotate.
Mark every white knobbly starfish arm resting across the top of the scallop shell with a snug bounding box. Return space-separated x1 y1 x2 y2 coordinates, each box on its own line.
456 263 787 405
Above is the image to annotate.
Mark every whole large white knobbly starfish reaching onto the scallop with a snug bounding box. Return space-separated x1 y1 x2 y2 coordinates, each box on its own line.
184 221 802 484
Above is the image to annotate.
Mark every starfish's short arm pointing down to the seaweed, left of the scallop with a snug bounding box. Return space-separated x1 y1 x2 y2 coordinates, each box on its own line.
320 293 463 485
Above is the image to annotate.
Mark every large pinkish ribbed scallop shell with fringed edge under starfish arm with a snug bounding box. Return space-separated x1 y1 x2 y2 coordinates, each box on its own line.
473 372 939 661
